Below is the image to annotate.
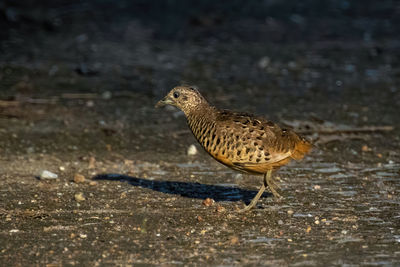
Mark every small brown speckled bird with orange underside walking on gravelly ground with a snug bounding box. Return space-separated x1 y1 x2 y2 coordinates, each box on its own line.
156 86 311 211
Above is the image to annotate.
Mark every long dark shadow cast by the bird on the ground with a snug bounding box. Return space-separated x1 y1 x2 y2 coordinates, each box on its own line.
93 174 271 204
